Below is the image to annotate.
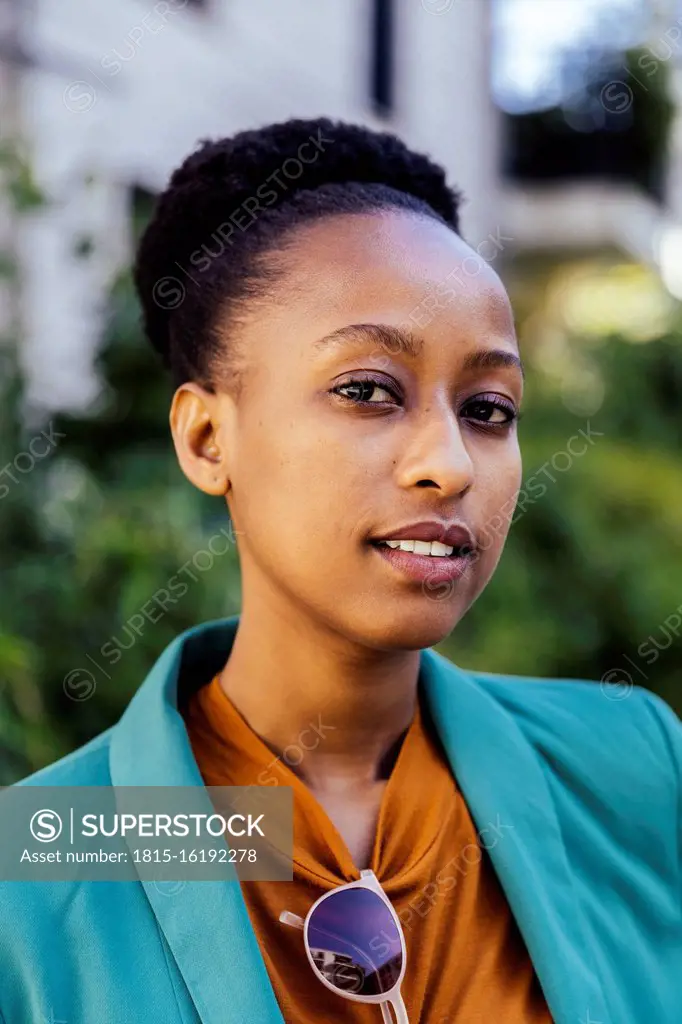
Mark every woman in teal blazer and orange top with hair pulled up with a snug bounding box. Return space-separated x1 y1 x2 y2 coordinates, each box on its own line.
0 119 682 1024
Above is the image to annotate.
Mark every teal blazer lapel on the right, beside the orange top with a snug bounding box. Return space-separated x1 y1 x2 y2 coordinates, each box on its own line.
420 649 609 1024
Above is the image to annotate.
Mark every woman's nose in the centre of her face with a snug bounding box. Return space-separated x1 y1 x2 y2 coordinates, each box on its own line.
397 403 474 498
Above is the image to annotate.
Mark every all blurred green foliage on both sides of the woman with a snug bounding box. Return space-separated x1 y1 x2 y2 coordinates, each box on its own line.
0 182 682 783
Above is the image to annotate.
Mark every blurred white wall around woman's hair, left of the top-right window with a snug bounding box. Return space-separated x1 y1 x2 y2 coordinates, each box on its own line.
0 0 497 408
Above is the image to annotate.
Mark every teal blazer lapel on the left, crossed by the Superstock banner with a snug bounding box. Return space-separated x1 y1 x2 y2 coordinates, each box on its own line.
110 617 284 1024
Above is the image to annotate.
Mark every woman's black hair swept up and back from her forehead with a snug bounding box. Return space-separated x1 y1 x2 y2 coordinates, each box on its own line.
134 118 462 390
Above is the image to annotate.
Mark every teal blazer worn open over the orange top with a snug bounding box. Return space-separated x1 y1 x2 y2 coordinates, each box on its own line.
0 616 682 1024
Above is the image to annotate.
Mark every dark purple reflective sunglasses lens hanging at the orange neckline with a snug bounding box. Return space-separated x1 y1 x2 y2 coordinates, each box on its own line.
307 888 402 995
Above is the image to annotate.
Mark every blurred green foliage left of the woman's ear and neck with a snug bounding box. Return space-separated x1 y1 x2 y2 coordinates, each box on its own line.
0 278 240 783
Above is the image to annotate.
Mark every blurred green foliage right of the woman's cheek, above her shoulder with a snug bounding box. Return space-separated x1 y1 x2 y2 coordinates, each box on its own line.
438 294 682 714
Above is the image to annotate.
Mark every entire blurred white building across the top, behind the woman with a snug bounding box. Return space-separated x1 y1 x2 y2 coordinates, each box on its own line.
0 0 682 408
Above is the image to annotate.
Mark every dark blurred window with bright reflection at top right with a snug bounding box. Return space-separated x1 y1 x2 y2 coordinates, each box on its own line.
493 0 673 201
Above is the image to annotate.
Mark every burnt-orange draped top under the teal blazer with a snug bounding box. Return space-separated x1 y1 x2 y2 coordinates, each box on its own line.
185 676 552 1024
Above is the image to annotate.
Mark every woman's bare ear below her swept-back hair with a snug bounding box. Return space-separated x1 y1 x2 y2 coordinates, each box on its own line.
170 382 229 496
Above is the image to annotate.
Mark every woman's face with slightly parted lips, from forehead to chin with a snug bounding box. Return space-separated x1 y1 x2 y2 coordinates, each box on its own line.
218 212 522 649
